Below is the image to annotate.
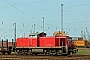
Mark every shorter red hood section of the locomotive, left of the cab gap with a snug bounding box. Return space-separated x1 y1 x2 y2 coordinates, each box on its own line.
16 37 37 48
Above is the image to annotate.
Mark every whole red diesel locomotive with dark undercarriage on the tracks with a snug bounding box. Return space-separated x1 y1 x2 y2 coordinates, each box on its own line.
16 32 76 55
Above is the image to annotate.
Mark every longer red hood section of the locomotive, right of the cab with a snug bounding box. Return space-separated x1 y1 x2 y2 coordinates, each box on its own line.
40 36 68 47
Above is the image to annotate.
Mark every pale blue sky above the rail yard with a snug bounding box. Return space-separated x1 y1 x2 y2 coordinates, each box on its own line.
0 0 90 40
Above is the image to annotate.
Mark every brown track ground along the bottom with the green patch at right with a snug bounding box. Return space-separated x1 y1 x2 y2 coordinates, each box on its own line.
0 48 90 60
